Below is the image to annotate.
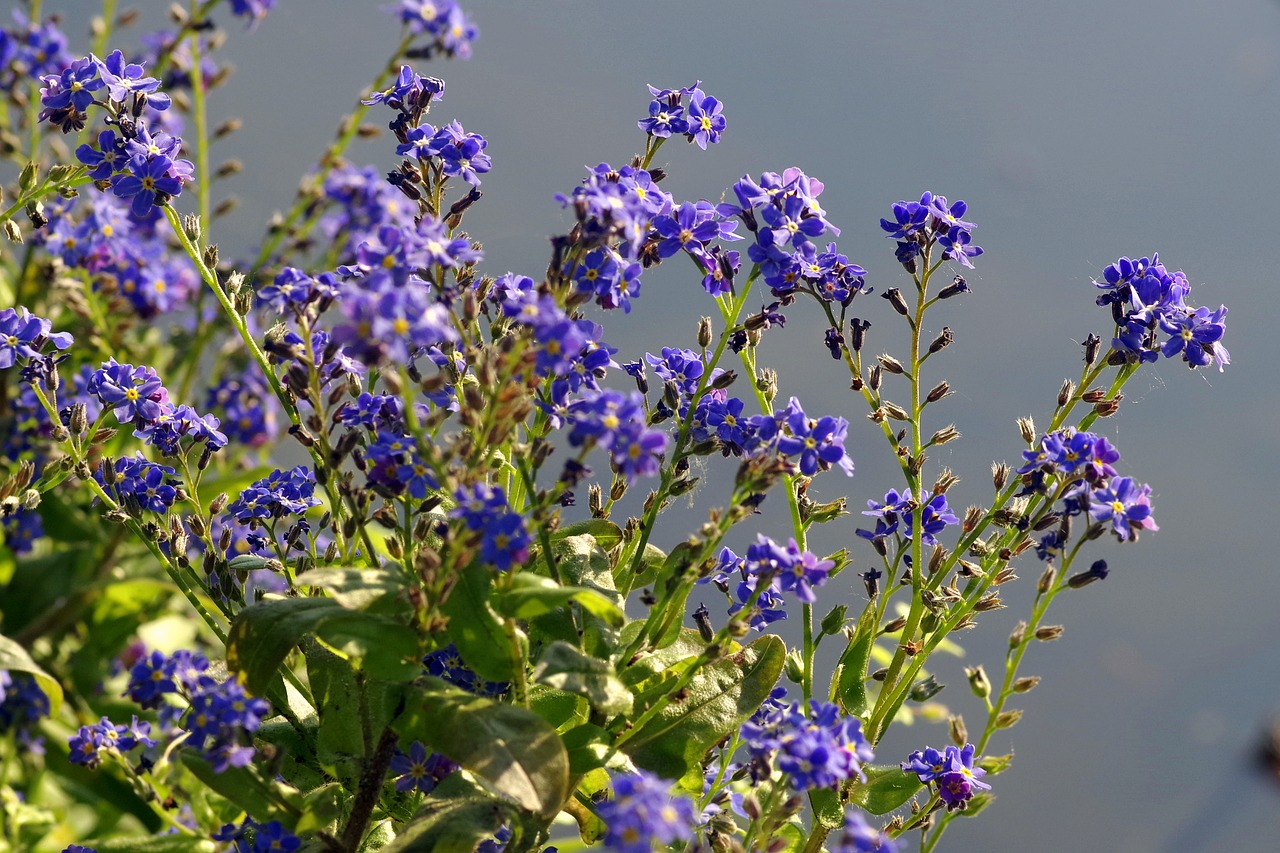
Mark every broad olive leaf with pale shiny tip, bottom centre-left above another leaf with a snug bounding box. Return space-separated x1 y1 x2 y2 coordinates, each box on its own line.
396 679 570 818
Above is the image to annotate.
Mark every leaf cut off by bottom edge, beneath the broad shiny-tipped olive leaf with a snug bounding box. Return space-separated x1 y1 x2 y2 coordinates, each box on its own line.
381 774 511 853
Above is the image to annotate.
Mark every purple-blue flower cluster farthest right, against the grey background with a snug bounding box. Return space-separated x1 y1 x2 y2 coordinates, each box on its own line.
1094 254 1231 370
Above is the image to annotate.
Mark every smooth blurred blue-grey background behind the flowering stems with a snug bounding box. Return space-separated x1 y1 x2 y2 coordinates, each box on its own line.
55 0 1280 853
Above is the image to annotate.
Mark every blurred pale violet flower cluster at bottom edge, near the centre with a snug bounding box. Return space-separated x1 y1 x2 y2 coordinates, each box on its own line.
596 770 695 853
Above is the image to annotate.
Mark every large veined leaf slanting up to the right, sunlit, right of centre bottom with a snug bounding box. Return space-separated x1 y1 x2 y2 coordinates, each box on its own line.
622 635 786 779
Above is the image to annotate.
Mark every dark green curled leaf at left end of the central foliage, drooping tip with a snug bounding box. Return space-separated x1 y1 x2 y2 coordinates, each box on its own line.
227 598 347 695
